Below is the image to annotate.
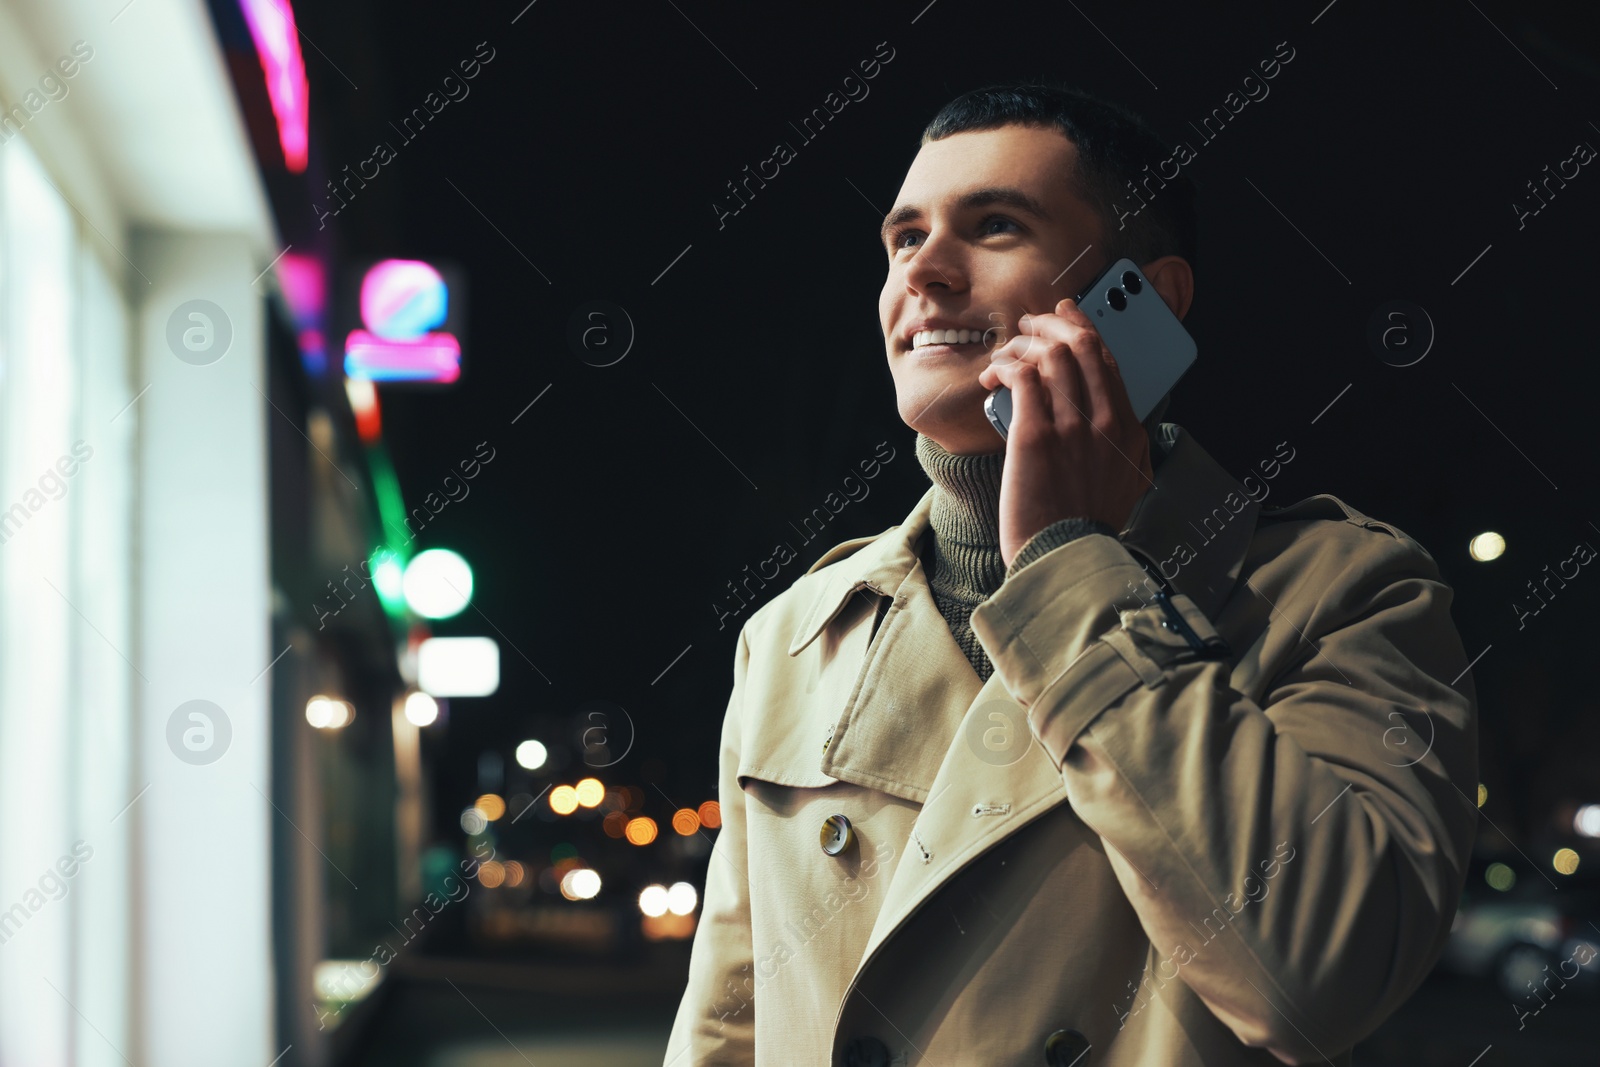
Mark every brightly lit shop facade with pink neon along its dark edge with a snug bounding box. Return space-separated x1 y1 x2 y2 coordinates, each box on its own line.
0 0 424 1067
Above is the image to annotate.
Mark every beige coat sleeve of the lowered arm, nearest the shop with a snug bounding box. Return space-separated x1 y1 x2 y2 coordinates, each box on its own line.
662 625 755 1067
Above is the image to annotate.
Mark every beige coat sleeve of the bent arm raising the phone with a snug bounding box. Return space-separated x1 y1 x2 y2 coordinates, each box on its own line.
973 523 1477 1064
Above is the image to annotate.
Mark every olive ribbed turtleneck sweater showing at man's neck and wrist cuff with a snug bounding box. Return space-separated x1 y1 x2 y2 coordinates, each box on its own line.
917 434 1118 681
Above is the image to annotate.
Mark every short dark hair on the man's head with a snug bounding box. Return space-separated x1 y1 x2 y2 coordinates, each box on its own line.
922 83 1198 275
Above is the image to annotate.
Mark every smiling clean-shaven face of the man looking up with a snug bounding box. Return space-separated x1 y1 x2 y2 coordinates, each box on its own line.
878 126 1106 454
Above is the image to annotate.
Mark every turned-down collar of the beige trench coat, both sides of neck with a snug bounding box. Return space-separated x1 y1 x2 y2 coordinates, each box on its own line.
789 422 1261 656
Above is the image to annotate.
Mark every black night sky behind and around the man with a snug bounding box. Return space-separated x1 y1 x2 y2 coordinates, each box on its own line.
288 0 1600 851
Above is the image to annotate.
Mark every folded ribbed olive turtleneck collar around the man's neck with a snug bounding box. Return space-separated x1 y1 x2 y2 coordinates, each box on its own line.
917 434 1005 605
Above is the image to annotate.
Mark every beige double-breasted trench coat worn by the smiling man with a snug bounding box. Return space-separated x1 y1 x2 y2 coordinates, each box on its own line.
664 422 1477 1067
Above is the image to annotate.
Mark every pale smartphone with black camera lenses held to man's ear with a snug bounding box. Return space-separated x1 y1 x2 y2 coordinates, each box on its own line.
984 259 1195 438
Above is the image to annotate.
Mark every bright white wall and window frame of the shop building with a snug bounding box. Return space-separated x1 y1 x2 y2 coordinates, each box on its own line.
0 0 278 1067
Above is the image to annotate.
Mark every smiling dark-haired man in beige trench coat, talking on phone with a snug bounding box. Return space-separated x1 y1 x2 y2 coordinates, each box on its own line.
666 86 1477 1067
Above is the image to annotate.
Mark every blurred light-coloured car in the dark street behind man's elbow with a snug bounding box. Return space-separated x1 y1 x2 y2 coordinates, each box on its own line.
1438 854 1600 1001
